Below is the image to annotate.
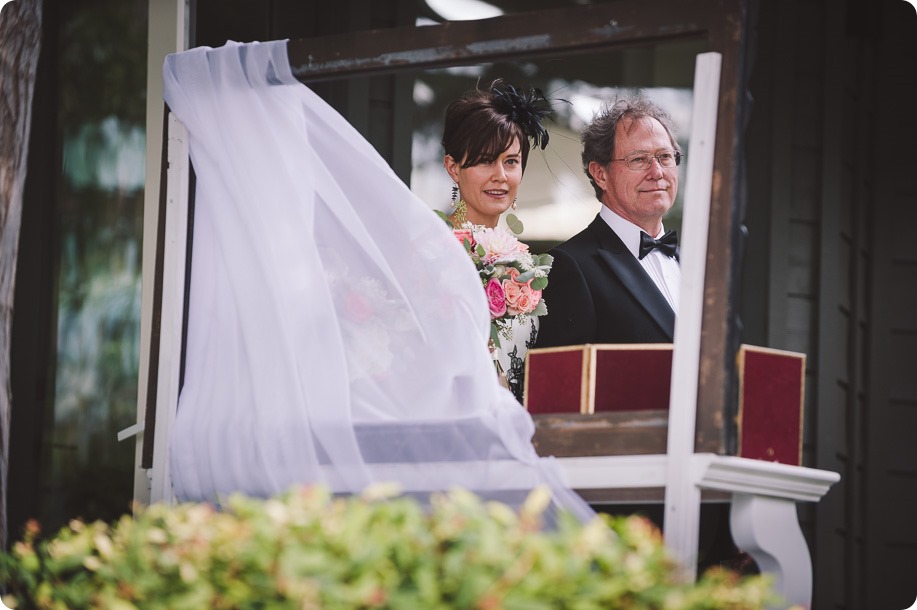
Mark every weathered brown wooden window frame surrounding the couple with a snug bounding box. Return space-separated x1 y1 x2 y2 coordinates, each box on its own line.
143 0 746 468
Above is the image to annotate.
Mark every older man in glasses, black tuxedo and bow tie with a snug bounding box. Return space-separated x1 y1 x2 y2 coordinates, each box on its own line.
536 97 681 347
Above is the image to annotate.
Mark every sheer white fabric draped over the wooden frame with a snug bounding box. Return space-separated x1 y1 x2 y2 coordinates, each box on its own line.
163 41 591 518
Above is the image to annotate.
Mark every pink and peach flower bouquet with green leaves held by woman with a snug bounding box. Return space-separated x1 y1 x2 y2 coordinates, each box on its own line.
452 222 554 348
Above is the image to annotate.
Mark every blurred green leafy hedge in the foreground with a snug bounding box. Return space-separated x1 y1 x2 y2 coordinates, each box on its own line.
0 486 773 610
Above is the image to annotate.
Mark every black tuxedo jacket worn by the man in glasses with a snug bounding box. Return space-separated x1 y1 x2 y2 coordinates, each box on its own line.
535 216 675 347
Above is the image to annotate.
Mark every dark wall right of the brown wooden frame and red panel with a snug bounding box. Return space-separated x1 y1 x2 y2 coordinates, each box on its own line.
741 0 917 609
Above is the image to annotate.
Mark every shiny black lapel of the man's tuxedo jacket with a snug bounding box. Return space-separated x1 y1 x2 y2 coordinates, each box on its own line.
590 217 675 340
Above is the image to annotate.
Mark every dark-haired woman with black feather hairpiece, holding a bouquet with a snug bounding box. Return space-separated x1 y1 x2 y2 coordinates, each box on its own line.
442 80 551 402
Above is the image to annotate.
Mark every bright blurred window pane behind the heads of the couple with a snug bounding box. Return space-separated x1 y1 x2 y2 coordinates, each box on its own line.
411 40 705 247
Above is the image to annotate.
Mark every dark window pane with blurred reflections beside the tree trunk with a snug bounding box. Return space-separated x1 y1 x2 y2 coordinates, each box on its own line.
40 0 147 528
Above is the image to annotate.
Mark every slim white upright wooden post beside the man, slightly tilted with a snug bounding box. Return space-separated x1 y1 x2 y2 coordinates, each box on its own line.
663 53 722 579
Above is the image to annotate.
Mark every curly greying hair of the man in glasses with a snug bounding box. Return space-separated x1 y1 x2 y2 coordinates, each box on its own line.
580 93 681 201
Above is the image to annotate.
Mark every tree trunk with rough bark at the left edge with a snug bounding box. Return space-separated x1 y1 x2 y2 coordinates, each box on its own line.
0 0 41 549
